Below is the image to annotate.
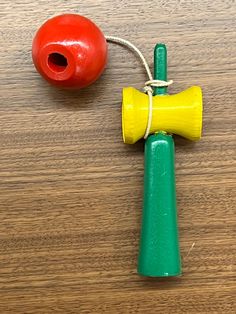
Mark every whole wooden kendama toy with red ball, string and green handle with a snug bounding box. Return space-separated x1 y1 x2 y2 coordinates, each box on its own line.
32 14 202 277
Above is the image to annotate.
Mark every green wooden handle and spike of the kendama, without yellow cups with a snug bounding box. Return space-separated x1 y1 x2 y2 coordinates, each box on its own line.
138 44 181 277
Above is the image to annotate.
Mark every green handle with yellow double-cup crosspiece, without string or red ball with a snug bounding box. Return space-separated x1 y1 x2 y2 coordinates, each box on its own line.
122 44 202 277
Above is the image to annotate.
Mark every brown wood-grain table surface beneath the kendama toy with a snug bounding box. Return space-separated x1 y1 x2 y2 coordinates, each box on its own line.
0 0 236 314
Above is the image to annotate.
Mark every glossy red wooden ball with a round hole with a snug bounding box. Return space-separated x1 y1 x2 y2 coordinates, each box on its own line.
32 14 107 88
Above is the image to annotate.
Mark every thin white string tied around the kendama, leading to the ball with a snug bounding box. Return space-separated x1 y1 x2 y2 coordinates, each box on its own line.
105 36 173 139
